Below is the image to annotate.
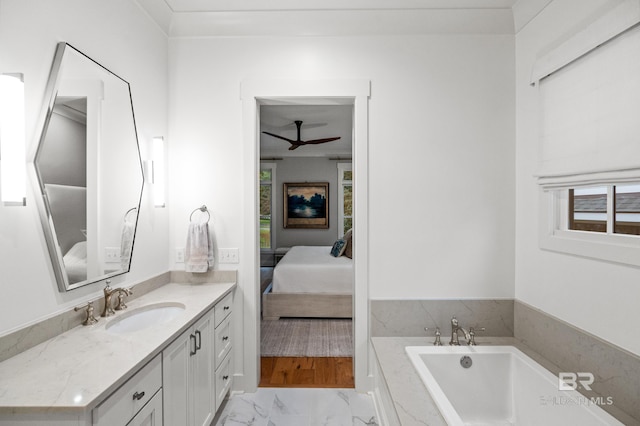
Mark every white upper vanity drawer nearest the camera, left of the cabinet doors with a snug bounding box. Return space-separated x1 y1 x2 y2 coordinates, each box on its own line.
93 355 162 426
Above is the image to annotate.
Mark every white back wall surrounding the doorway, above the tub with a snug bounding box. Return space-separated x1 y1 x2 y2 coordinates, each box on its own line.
169 35 515 299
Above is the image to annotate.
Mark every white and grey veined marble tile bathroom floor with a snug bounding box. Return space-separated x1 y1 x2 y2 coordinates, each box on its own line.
214 388 379 426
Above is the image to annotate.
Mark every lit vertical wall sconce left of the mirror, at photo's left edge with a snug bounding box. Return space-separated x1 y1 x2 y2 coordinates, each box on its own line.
0 74 26 206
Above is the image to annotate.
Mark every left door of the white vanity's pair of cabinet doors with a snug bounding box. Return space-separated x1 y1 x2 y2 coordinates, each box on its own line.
162 330 191 426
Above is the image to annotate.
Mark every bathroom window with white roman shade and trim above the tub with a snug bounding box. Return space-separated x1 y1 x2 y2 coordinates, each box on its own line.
531 2 640 266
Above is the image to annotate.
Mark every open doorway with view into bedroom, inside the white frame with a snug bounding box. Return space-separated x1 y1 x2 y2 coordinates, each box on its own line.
257 105 355 388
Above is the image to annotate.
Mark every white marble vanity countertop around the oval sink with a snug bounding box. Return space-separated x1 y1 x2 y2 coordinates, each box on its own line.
0 282 236 414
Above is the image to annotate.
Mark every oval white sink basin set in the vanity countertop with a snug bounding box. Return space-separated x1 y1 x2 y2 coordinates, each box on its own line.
105 302 185 334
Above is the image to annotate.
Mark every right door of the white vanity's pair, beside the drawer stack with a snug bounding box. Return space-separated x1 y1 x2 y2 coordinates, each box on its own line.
191 312 215 426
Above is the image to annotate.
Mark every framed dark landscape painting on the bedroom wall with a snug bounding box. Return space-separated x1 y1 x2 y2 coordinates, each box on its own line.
283 182 329 229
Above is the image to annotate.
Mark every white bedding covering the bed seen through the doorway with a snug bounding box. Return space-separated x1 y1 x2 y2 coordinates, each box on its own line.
272 246 353 294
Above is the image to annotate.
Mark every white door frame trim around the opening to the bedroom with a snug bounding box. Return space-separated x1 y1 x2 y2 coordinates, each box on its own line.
239 80 373 392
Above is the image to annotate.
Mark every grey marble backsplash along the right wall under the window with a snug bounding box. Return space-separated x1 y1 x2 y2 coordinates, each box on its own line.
514 301 640 425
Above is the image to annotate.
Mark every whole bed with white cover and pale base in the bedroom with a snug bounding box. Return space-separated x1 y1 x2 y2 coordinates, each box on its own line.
262 246 353 320
